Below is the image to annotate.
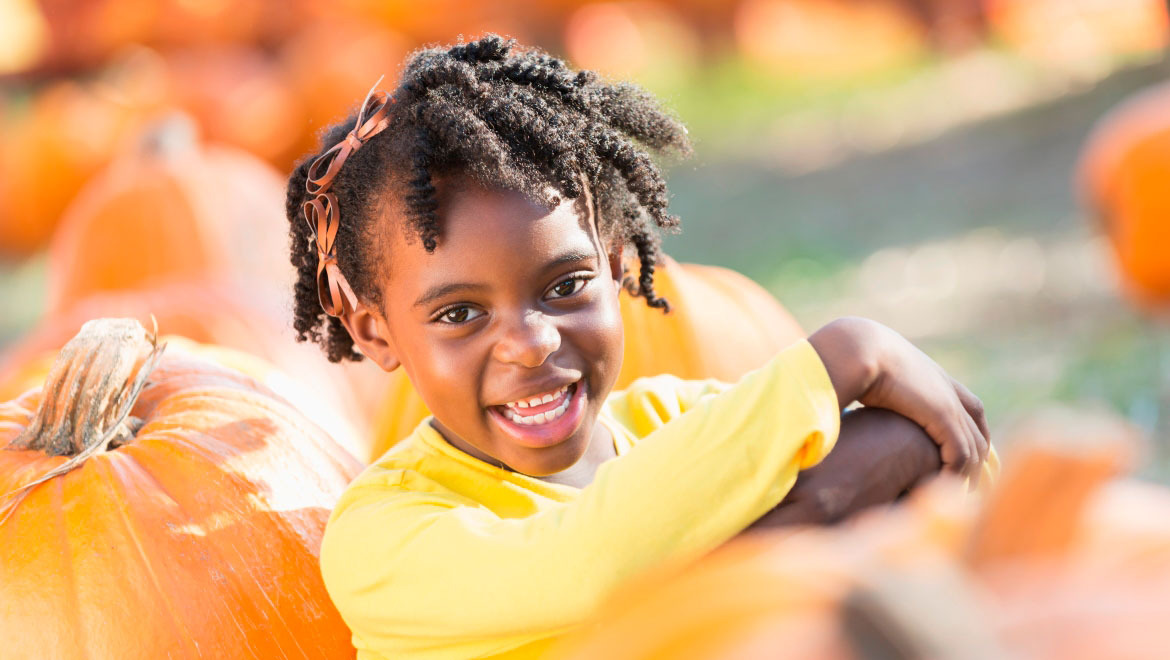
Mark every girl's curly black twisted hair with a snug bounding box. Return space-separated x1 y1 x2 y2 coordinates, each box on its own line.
285 35 690 362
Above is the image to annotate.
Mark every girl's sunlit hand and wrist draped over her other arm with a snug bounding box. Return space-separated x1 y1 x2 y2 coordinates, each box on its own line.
808 318 991 480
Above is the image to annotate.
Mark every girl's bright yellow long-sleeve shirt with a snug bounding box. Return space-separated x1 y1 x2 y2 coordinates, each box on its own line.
321 341 840 660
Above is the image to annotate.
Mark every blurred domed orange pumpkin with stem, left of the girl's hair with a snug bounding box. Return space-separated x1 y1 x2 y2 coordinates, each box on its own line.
47 117 293 314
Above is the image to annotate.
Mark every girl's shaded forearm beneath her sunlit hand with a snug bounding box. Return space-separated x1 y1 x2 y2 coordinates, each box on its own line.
749 408 942 529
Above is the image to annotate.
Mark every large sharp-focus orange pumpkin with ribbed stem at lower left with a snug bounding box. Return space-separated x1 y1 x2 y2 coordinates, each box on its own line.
0 319 360 660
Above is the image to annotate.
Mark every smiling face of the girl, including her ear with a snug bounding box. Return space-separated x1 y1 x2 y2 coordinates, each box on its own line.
347 180 622 476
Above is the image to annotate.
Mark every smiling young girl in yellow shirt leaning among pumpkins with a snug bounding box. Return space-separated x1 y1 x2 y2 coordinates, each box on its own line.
288 36 989 659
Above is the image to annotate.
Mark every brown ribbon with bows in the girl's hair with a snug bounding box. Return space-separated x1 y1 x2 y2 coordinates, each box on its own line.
302 78 394 316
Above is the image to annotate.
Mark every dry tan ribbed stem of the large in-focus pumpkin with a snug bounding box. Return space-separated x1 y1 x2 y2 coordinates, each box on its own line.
11 318 165 456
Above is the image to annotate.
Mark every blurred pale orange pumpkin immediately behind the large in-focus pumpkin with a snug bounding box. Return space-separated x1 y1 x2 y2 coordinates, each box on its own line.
0 281 376 462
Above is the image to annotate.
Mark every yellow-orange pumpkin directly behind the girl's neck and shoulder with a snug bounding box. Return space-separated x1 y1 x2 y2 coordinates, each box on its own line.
373 257 804 456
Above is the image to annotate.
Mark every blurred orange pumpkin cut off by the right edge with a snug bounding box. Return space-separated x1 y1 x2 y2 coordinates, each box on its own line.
1078 84 1170 305
